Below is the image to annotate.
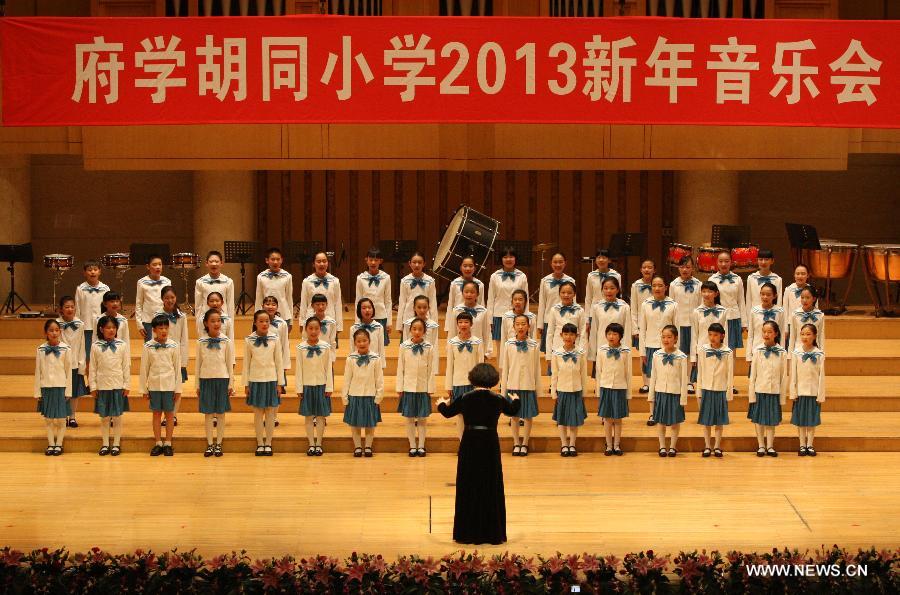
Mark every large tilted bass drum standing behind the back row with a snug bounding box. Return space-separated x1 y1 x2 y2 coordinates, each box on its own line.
432 206 500 281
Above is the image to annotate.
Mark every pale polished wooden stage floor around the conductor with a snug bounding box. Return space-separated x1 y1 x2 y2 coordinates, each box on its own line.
0 452 900 557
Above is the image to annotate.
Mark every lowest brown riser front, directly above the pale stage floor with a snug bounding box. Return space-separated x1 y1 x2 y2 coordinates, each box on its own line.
0 436 900 454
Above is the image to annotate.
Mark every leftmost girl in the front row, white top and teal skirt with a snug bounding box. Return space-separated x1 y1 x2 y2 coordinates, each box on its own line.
34 320 73 457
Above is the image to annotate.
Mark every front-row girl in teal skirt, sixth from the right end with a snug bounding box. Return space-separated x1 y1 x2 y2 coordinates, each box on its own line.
547 322 589 457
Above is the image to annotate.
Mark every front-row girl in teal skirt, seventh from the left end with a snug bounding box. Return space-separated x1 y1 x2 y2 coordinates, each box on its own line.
341 329 384 457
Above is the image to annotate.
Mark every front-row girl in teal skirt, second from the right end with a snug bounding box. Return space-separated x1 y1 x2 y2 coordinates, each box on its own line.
748 320 789 457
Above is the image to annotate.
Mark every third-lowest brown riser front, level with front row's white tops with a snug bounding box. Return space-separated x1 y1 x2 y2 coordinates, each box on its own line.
0 353 900 376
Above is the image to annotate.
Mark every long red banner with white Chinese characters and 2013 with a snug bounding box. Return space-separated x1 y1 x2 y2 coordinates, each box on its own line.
0 16 900 128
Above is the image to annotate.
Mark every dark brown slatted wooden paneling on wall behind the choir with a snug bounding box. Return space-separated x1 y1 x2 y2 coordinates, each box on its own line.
260 170 673 299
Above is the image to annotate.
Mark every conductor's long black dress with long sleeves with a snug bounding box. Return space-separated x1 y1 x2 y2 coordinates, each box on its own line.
438 390 519 544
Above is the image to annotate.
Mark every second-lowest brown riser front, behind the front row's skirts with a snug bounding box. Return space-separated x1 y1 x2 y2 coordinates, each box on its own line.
0 394 900 414
